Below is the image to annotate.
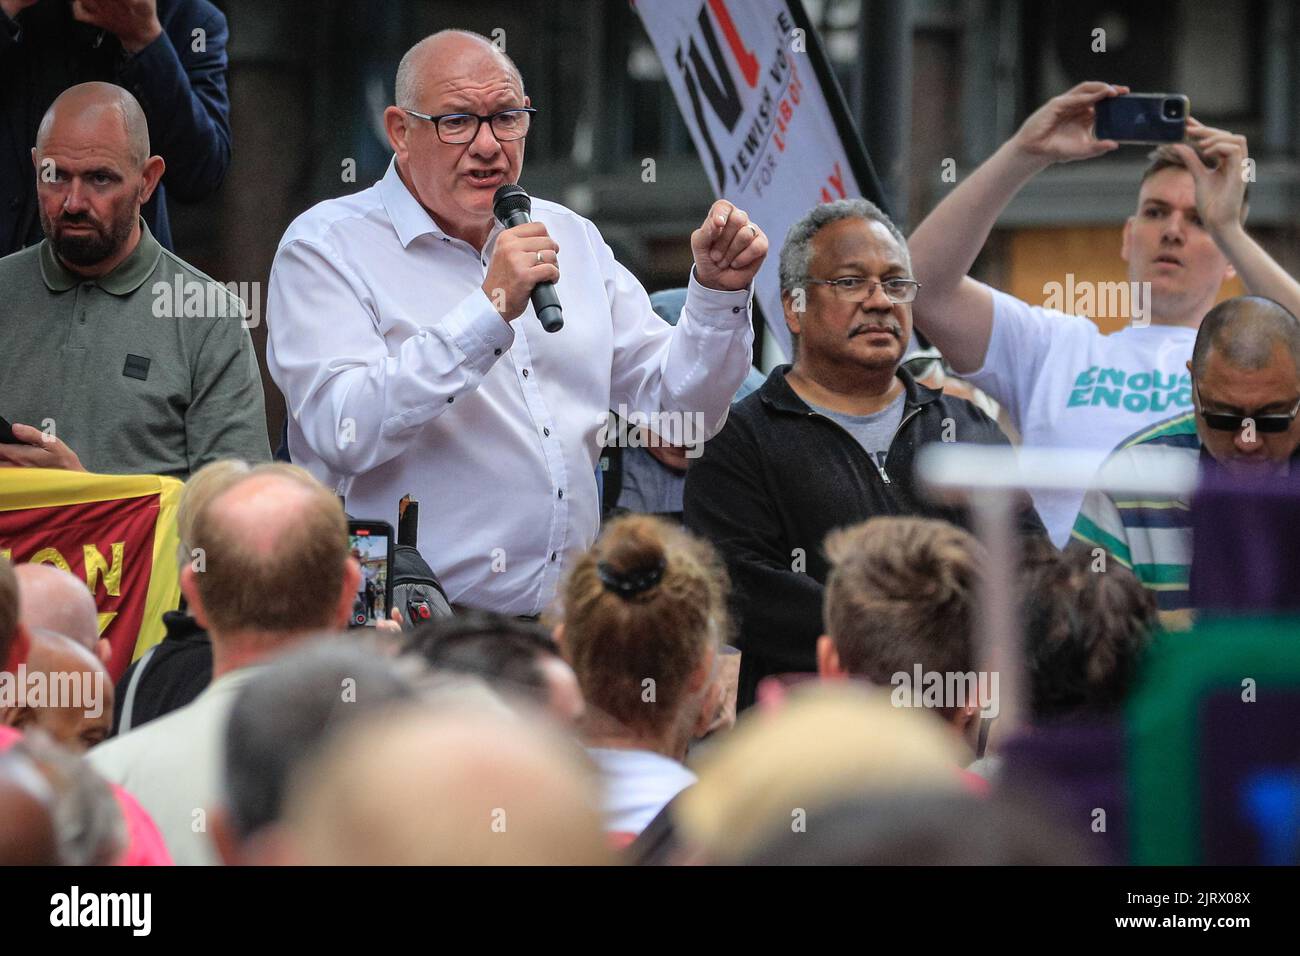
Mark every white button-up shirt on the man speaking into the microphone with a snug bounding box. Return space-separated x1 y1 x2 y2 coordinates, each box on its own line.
267 164 753 614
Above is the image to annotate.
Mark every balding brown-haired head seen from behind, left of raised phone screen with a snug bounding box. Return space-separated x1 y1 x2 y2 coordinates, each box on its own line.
182 464 359 640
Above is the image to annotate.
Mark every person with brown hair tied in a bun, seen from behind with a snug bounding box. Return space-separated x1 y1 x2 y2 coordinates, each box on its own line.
558 515 728 840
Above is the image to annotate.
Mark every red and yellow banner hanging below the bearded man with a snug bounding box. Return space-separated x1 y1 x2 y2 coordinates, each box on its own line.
0 468 183 680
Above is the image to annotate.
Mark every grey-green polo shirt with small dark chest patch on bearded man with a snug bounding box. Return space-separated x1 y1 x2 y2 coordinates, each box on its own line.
0 220 270 479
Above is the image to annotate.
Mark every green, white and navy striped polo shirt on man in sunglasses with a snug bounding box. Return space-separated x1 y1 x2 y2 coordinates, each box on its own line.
1070 411 1201 631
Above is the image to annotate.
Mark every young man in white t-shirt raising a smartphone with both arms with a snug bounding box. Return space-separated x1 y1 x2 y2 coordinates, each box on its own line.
909 82 1300 546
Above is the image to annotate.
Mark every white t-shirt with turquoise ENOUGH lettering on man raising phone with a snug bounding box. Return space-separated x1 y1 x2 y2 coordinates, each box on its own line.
963 289 1196 548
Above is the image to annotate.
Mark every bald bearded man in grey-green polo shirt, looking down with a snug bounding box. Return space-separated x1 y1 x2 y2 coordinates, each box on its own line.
0 83 270 479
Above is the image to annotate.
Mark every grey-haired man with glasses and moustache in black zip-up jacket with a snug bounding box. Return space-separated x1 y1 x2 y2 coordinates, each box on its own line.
685 199 1043 706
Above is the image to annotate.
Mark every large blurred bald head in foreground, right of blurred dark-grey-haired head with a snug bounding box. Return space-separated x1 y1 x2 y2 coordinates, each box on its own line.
286 708 608 865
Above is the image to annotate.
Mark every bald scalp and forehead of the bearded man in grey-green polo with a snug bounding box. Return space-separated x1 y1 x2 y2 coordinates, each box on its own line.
36 82 150 169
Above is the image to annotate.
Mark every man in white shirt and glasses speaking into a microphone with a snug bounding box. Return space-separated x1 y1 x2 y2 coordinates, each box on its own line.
267 30 768 615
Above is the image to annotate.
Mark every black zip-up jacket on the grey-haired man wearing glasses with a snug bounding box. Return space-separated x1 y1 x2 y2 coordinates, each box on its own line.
685 365 1047 706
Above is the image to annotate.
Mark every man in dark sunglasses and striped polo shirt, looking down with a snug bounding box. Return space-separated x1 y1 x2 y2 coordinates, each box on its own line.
1070 295 1300 630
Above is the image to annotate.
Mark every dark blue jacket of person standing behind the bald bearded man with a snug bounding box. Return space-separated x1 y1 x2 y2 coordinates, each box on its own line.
0 0 230 256
